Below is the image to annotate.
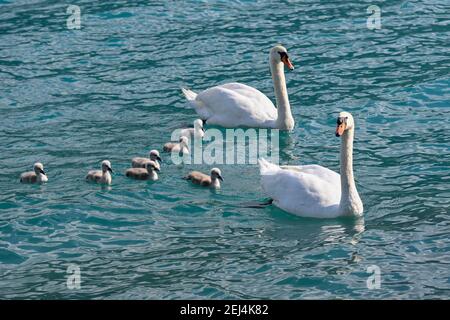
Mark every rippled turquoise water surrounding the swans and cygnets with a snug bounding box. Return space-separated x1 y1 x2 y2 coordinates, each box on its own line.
0 0 450 299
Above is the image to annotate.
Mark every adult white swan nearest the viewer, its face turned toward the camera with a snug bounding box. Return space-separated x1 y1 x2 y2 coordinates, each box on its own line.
259 112 363 218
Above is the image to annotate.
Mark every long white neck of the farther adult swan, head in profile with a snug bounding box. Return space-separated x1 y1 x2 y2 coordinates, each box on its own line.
270 59 294 130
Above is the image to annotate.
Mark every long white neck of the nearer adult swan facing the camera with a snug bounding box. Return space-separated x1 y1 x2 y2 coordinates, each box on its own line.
339 128 363 216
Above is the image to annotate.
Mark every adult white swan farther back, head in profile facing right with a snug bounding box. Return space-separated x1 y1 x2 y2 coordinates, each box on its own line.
181 46 294 130
